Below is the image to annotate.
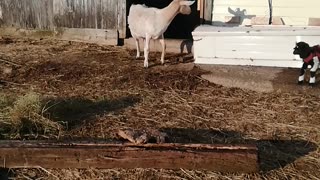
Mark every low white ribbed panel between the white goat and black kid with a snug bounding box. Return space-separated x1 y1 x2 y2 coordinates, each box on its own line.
193 26 320 67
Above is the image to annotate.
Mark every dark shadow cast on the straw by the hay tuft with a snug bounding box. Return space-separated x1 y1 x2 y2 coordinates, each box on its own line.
45 96 141 130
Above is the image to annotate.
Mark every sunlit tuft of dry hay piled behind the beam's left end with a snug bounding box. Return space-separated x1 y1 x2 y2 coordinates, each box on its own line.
0 92 62 139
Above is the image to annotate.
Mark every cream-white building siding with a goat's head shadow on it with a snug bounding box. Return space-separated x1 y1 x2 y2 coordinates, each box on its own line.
212 0 320 26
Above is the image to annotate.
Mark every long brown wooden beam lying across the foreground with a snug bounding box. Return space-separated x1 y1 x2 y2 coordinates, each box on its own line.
0 141 258 173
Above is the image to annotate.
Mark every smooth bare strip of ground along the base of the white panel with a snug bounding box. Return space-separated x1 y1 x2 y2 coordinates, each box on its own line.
199 65 320 95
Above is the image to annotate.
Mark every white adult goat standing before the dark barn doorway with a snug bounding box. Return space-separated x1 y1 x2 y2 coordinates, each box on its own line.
128 0 195 68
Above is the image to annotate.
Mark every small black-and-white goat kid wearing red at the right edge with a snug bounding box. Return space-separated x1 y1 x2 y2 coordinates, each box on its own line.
293 42 320 85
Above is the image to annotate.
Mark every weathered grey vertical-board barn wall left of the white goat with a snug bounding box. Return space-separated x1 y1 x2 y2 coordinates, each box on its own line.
0 0 126 43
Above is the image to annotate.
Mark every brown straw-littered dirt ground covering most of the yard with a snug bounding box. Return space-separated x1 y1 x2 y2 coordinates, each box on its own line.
0 37 320 179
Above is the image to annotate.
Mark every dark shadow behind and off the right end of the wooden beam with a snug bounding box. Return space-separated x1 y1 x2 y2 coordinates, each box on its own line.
161 128 317 173
